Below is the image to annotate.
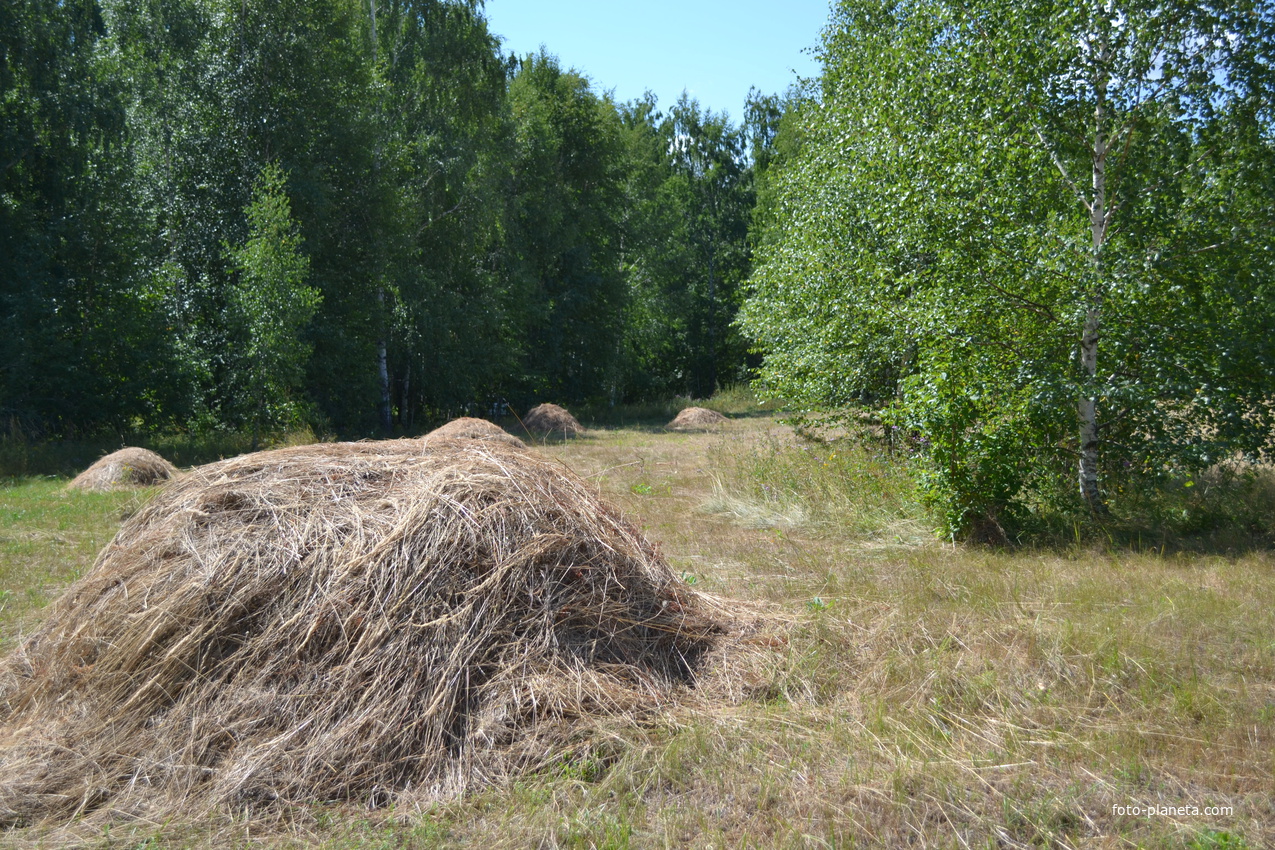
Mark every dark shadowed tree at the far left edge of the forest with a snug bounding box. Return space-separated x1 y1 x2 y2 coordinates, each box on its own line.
0 0 177 436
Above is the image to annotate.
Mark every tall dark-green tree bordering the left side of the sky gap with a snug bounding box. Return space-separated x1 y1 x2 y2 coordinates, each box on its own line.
367 0 524 429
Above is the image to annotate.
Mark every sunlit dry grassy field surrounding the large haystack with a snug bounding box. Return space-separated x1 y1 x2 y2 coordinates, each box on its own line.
0 401 1275 850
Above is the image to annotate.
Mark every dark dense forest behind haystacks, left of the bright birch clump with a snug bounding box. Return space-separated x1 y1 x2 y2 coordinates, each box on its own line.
0 0 779 438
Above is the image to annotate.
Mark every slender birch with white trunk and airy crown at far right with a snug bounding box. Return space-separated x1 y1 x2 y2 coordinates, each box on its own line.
999 3 1272 512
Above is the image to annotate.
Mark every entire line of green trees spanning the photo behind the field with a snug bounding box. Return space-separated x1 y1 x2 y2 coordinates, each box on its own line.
7 0 1275 539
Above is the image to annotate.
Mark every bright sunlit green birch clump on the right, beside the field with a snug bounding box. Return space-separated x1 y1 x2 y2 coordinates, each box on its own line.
741 0 1275 538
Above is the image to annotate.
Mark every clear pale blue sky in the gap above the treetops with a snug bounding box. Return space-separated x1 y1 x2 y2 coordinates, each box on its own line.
486 0 829 124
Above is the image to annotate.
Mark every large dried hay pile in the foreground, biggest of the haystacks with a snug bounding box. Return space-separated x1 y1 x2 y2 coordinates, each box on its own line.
0 440 722 825
